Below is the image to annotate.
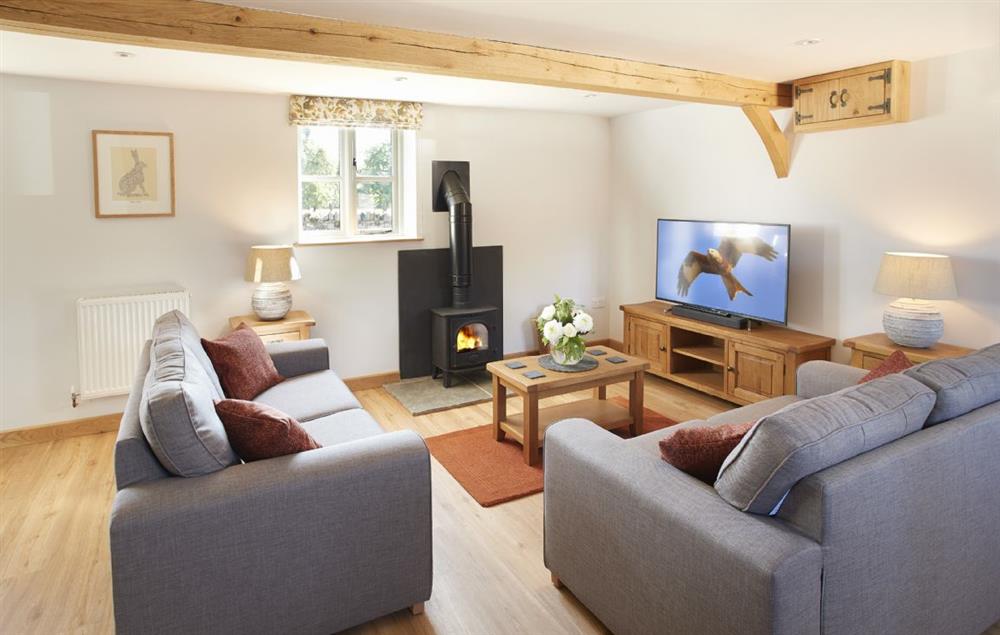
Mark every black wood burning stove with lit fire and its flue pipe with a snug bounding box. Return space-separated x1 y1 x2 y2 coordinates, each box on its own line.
431 161 503 388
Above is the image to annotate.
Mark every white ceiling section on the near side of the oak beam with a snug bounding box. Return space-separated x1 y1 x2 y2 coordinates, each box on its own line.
217 0 1000 82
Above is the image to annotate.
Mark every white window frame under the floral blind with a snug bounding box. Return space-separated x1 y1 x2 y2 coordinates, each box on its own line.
295 126 415 244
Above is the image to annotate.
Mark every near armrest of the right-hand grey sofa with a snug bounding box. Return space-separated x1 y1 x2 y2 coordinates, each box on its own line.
544 419 822 634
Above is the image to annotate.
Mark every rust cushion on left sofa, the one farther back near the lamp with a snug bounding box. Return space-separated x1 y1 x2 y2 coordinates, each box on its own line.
201 324 285 401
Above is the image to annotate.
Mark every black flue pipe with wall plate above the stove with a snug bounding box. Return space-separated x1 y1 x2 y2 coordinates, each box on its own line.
432 161 472 308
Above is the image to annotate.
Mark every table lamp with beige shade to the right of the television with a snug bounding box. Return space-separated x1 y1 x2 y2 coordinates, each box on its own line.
875 251 958 348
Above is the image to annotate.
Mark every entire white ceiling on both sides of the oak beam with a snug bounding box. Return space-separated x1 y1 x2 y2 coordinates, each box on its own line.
0 0 1000 116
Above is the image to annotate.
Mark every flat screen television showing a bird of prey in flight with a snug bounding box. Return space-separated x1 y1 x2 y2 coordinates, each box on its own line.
656 218 791 324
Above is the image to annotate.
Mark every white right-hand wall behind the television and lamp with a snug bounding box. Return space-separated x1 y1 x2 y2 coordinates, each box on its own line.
609 48 1000 359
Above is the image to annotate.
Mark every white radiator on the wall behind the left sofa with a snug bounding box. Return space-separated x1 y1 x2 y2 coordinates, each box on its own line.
73 291 190 405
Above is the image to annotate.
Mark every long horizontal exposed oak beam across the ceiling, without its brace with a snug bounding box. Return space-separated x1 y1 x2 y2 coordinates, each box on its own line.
0 0 792 108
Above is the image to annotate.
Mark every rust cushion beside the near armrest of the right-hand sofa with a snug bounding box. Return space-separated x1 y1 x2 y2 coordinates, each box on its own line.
660 421 755 485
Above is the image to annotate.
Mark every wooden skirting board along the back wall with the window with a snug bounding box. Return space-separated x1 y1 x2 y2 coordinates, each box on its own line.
0 339 624 449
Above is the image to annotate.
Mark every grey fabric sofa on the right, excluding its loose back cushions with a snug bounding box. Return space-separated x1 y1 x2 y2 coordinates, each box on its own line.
544 362 1000 635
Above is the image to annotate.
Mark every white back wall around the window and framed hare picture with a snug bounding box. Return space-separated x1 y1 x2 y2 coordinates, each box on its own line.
0 76 610 428
